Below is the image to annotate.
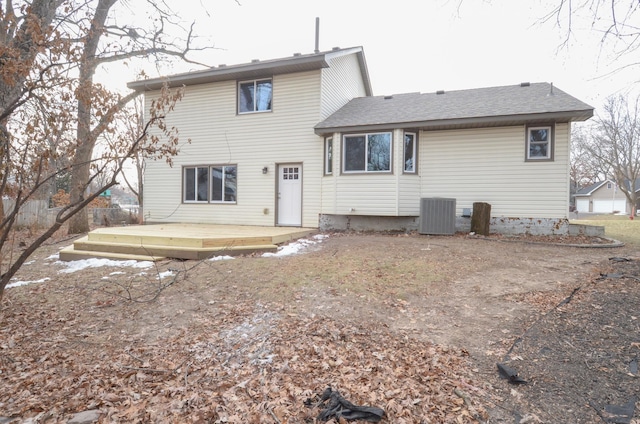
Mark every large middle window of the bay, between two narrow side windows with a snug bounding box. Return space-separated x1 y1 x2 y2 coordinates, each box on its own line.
342 132 391 173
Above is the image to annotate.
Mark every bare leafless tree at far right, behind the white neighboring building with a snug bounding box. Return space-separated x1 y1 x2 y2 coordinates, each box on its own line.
583 96 640 217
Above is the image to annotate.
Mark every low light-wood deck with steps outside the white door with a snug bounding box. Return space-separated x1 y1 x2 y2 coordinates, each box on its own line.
60 224 317 261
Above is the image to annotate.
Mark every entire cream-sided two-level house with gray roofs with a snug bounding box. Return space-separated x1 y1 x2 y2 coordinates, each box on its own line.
128 47 593 232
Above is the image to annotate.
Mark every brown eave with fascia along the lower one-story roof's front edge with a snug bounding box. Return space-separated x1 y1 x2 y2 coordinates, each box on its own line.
314 109 593 136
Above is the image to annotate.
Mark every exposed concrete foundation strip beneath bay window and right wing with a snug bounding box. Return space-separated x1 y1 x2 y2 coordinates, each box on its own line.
319 214 604 236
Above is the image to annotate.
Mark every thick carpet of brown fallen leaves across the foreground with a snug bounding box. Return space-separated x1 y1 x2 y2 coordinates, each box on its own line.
0 299 486 423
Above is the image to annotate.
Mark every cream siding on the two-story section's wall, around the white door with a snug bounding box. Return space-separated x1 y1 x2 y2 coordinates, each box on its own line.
144 71 324 227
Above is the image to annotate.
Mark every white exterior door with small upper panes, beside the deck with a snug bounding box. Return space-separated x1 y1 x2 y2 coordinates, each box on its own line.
277 163 302 227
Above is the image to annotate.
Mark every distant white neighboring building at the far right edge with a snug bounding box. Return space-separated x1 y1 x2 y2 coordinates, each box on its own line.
575 180 640 214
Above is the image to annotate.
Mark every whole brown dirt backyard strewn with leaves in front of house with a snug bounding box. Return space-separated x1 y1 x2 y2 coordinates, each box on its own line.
0 230 640 424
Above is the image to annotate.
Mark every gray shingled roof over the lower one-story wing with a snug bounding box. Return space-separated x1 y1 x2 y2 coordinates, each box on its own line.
315 83 593 134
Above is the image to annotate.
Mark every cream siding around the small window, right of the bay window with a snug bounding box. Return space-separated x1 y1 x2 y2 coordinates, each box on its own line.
415 124 569 218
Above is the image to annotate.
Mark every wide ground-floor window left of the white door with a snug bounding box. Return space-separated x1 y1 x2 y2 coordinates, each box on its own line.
182 165 238 203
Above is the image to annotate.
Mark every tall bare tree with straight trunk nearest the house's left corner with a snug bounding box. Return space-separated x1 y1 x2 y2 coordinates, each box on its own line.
63 0 208 234
